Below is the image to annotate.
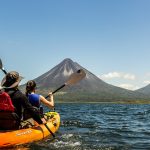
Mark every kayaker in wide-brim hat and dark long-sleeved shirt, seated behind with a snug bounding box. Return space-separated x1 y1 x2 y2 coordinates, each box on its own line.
0 71 45 130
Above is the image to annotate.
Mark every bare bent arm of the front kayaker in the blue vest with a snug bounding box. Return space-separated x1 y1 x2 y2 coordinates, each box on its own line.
40 93 54 108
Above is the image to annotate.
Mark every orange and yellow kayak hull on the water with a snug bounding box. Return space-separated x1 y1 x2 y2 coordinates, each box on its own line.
0 112 60 148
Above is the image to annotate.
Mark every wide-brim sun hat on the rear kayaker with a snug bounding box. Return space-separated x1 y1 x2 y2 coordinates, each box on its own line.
1 71 23 88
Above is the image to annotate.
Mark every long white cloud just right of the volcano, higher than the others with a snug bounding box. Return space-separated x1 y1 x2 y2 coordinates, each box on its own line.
100 72 135 80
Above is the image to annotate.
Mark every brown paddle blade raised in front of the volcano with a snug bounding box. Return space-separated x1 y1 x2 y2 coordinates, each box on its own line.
65 69 86 85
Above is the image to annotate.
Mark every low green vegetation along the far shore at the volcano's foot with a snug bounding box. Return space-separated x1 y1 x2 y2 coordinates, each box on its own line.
20 87 150 104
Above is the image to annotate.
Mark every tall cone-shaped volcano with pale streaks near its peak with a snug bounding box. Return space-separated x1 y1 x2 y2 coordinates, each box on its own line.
20 58 150 101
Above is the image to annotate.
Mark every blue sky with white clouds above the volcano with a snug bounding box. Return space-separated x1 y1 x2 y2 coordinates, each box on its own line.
0 0 150 90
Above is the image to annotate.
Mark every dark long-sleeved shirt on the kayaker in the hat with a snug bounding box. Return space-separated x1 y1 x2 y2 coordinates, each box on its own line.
7 89 42 124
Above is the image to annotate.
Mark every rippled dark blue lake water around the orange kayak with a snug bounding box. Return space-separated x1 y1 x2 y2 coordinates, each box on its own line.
19 104 150 150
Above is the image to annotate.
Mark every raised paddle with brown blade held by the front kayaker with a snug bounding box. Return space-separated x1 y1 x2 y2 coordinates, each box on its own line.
45 69 86 98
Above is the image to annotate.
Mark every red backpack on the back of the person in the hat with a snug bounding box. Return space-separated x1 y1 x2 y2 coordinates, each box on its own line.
0 91 15 112
